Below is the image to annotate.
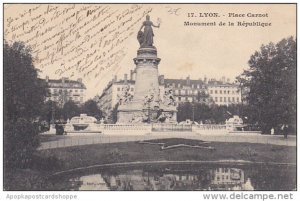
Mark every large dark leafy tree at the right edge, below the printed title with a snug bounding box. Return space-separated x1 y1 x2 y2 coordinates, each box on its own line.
243 37 297 132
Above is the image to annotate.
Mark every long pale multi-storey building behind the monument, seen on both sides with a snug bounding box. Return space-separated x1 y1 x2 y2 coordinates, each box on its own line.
95 71 241 118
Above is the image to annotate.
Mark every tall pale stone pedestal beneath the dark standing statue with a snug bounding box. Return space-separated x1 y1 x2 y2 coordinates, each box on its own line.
118 47 177 123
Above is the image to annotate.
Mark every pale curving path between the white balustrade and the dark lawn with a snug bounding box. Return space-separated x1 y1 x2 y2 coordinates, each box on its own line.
39 132 296 149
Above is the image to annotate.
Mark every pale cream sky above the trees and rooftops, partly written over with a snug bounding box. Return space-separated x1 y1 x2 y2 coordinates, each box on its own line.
4 4 296 98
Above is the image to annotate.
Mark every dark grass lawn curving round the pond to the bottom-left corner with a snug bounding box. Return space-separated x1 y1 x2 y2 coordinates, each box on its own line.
4 138 296 190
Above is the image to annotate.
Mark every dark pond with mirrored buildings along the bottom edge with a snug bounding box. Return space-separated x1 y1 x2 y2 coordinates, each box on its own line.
52 165 296 191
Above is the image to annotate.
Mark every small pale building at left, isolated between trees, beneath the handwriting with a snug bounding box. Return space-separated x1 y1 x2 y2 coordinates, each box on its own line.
46 76 86 107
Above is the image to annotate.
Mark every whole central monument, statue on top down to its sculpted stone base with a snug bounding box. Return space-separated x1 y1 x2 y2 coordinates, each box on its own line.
117 15 177 123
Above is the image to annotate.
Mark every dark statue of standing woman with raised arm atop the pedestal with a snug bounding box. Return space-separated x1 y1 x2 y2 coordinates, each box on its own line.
137 15 160 47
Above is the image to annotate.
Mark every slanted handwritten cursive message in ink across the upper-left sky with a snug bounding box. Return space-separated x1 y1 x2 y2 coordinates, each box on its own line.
4 4 152 85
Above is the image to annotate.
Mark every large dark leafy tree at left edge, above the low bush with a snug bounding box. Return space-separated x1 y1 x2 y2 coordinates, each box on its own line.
3 42 47 121
